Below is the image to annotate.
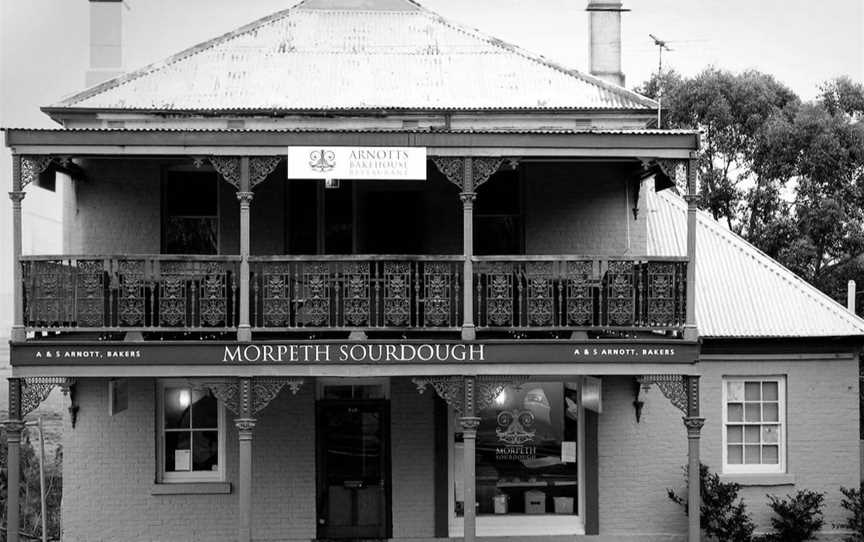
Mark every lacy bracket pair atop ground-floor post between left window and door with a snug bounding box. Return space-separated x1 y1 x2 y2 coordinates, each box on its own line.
200 377 303 418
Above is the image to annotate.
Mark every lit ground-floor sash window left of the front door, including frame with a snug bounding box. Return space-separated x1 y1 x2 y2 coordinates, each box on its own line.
158 381 225 482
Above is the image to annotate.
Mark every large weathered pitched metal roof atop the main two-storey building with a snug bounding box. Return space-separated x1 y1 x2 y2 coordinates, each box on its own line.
46 0 656 112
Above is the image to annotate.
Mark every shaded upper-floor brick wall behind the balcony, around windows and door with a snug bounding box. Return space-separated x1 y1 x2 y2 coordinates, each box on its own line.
62 159 647 256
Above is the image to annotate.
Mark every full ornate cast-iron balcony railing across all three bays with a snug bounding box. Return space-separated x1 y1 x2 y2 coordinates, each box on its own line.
21 255 687 338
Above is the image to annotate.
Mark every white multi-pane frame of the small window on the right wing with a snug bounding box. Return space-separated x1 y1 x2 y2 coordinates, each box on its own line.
721 375 787 474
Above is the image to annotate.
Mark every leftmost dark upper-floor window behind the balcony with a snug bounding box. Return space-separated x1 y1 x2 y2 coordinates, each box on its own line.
163 171 219 254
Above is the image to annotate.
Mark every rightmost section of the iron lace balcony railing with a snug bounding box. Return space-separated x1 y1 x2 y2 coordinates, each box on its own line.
474 256 687 330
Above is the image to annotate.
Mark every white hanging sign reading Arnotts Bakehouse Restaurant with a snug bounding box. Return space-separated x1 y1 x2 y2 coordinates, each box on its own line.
288 147 426 181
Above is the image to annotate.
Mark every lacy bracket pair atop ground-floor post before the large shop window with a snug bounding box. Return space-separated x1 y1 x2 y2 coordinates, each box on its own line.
412 376 528 416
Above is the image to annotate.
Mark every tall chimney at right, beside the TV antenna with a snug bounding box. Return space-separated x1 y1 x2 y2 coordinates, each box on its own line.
585 0 629 87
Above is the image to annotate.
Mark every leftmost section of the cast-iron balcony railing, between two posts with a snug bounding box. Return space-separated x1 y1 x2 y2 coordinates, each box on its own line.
21 255 239 332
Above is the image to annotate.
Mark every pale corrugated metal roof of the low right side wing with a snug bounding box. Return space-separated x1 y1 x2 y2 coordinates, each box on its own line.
646 190 864 337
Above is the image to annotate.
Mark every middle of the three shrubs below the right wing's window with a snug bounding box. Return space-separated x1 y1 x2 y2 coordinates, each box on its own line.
760 489 825 542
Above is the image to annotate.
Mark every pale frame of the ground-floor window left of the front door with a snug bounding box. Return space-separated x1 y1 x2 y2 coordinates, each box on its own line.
156 379 226 484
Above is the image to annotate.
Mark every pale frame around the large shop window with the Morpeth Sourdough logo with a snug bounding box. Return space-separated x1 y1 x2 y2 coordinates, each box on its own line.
447 377 586 538
